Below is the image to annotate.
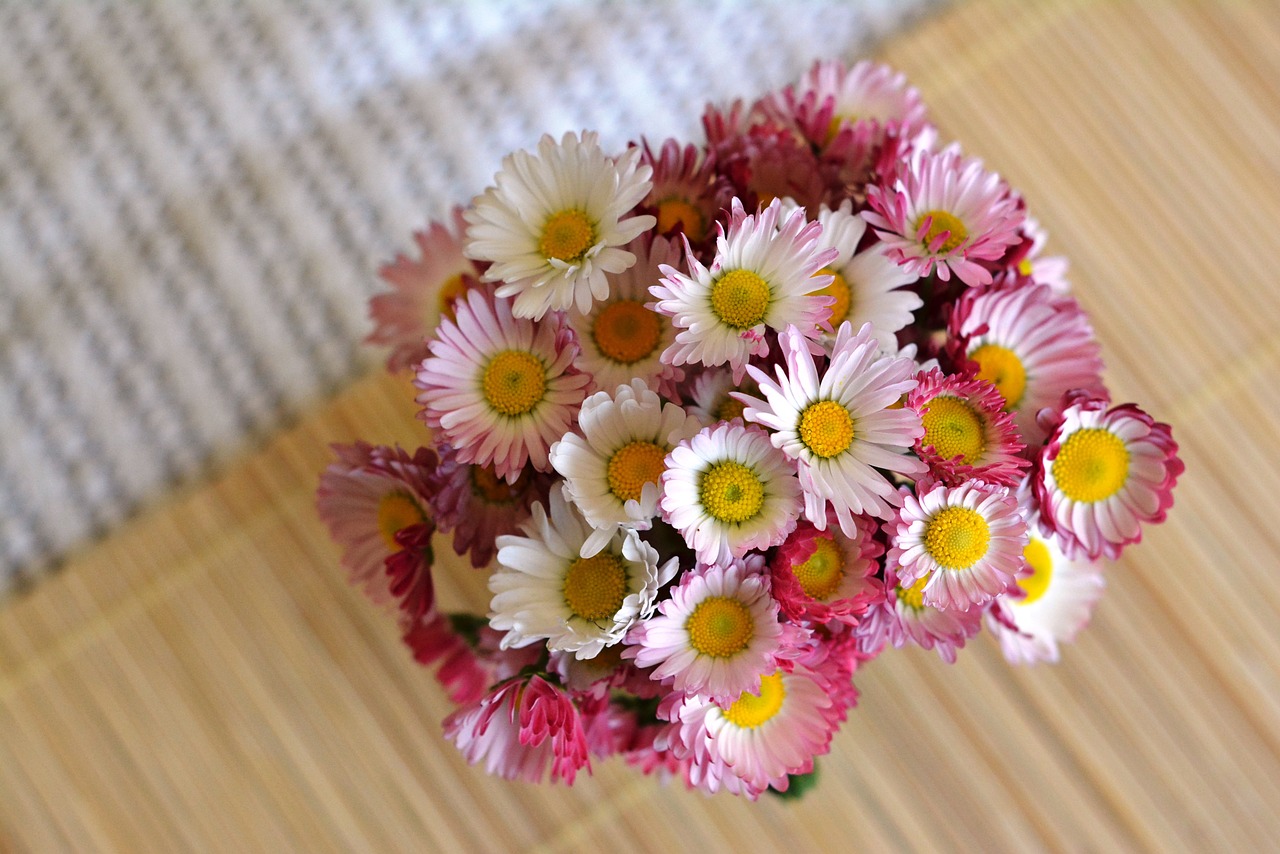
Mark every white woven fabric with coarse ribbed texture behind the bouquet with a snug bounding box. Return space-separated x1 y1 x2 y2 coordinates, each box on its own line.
0 0 938 589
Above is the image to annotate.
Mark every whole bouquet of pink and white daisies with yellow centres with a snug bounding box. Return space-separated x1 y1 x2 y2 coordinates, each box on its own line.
319 61 1183 798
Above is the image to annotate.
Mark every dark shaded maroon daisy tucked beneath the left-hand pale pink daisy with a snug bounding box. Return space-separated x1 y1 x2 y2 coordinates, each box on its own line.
430 444 550 570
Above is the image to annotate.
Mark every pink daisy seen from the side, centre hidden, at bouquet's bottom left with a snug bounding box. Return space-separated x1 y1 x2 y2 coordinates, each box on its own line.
444 675 591 785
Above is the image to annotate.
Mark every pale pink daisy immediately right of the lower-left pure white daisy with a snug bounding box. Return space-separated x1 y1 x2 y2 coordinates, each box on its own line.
622 560 783 703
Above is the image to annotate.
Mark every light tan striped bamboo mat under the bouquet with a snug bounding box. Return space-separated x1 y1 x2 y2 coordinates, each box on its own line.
0 0 1280 851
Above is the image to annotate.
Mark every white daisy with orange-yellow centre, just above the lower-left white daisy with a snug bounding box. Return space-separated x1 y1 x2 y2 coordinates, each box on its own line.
550 379 701 557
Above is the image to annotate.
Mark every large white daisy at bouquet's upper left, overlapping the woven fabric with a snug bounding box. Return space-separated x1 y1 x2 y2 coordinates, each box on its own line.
466 132 657 320
